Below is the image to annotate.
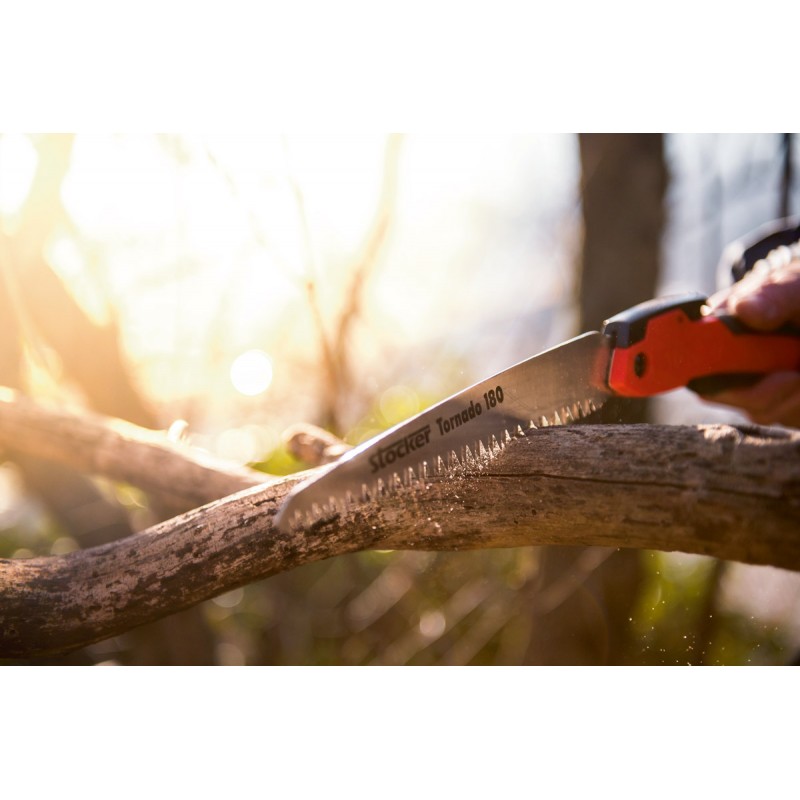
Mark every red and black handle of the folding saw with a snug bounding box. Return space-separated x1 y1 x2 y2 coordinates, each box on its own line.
603 295 800 397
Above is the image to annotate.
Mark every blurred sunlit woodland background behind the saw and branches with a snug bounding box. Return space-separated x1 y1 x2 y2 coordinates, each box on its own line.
0 134 800 665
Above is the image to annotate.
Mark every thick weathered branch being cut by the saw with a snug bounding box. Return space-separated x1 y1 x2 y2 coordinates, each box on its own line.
0 418 800 657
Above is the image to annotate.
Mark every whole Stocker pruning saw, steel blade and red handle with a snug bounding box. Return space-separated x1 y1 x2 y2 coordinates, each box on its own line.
275 294 800 531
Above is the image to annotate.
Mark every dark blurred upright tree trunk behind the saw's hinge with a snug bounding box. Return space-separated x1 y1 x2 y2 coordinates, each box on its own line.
527 134 668 664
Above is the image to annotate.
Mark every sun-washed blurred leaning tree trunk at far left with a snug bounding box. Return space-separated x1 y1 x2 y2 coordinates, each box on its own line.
0 134 214 664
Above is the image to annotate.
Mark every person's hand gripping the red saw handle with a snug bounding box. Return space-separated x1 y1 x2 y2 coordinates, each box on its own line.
704 252 800 427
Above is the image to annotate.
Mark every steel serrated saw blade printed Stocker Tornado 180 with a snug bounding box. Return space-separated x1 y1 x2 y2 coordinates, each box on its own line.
275 332 610 530
